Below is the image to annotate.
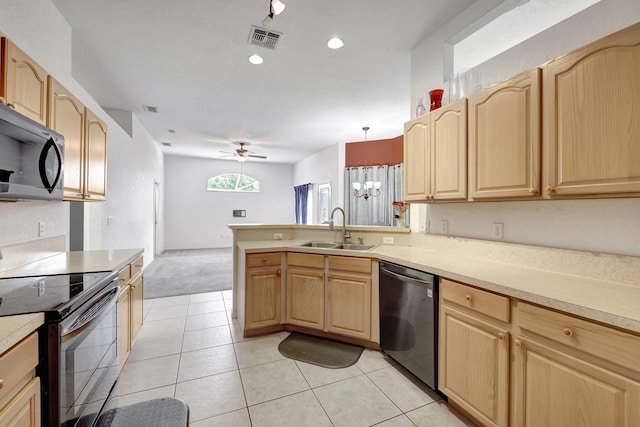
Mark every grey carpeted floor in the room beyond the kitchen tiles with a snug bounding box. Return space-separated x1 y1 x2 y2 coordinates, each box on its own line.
144 248 233 299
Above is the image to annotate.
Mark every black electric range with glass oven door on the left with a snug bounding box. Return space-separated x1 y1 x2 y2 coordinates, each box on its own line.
0 272 120 427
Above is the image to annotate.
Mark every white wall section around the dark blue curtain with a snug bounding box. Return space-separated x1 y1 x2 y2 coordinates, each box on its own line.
293 144 345 224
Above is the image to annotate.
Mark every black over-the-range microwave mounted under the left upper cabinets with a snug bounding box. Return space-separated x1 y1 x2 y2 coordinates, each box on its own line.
0 103 64 201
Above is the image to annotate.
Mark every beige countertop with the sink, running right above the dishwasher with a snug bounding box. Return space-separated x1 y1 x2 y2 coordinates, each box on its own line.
237 240 640 333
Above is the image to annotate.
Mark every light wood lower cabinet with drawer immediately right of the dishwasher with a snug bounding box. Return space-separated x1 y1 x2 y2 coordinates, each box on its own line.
438 279 510 426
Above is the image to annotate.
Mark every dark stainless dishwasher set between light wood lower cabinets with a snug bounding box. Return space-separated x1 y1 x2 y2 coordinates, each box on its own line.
380 261 438 390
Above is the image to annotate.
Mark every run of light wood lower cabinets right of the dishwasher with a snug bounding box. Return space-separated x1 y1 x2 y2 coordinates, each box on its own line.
439 279 640 427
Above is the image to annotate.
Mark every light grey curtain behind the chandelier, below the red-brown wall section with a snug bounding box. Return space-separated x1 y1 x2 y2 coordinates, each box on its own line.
344 163 409 227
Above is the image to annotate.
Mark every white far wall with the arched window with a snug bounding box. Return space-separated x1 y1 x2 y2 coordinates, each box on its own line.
165 156 295 249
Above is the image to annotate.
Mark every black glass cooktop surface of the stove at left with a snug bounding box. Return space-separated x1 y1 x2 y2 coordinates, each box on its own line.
0 271 116 319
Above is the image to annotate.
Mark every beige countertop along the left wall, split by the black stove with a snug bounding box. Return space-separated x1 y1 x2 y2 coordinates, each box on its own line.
0 249 143 353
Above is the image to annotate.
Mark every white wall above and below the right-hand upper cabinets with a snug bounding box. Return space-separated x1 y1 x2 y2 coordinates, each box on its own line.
411 0 640 256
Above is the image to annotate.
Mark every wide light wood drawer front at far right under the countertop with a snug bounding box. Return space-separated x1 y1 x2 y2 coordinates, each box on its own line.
518 301 640 372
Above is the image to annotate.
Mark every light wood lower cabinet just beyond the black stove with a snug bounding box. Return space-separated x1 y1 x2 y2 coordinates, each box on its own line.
118 257 144 368
